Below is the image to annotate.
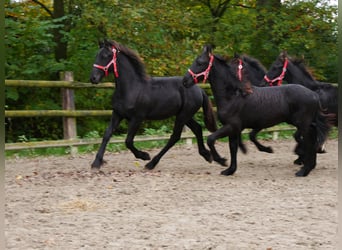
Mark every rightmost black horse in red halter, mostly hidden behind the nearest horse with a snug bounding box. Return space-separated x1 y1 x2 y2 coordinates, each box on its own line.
264 51 338 127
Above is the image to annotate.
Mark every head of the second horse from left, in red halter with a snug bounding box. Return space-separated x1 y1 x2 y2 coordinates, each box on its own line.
183 45 214 88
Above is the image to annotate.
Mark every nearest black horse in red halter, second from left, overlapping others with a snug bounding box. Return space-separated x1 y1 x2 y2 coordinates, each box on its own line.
183 46 329 176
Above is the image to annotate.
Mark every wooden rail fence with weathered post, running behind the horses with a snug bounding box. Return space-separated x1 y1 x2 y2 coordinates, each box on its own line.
5 72 294 153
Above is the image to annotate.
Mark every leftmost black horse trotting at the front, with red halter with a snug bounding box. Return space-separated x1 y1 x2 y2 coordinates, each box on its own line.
90 41 216 169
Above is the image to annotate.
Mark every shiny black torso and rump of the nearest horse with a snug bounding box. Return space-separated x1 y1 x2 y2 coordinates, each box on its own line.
239 85 319 128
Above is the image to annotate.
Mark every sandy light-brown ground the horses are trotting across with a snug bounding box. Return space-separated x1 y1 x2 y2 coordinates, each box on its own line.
5 140 338 250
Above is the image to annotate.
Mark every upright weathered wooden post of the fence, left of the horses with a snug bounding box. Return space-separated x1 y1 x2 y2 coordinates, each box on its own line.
60 71 77 156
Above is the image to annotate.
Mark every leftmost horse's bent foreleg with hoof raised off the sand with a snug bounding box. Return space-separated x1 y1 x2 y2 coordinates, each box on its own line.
125 118 151 161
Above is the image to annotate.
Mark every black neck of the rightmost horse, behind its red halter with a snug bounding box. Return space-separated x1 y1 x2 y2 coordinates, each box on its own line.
284 62 317 89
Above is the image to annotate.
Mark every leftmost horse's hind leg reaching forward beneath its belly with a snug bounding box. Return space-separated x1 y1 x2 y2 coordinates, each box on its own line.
145 117 184 169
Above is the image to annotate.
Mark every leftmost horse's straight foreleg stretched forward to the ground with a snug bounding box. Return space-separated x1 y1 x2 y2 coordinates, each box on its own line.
91 111 122 169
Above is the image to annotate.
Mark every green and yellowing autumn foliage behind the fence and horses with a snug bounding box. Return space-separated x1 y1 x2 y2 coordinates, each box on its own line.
4 0 338 141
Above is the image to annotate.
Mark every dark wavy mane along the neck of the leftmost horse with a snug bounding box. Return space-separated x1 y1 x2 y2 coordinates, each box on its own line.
106 40 149 80
